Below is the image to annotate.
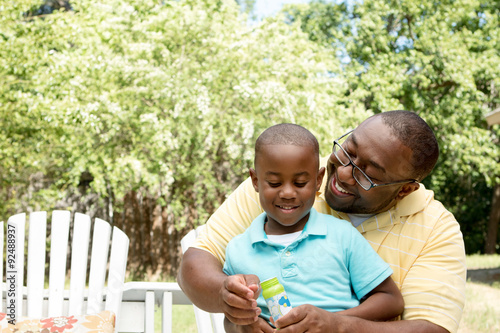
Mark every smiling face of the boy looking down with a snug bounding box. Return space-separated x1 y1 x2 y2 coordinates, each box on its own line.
250 145 325 235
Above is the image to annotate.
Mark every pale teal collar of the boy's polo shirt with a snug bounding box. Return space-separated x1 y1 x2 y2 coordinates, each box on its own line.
249 208 327 244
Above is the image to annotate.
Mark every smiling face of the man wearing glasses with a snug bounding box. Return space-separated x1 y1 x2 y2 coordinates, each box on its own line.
325 117 418 214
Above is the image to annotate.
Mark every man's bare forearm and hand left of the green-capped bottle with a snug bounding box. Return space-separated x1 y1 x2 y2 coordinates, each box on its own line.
177 248 261 325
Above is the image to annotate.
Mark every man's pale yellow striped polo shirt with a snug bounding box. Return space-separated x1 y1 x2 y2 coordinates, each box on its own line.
193 160 467 332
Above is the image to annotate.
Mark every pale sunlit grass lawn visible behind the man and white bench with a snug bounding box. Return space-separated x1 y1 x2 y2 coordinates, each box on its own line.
161 255 500 333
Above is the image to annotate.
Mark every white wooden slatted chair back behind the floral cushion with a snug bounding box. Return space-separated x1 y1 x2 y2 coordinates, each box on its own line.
0 211 129 330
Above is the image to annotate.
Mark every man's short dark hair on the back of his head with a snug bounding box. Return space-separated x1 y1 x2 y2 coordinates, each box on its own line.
374 110 439 181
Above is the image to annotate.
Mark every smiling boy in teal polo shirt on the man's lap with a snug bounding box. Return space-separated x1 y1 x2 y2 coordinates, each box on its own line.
224 124 403 325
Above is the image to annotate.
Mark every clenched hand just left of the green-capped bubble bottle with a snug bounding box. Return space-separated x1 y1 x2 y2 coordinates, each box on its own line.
220 274 261 325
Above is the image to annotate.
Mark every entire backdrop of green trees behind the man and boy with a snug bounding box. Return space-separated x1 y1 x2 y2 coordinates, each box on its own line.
0 0 500 279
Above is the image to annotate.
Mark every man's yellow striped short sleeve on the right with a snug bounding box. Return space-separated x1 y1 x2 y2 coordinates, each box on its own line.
401 209 466 333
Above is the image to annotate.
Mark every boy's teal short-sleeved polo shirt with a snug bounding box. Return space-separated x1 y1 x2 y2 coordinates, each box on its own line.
224 208 392 319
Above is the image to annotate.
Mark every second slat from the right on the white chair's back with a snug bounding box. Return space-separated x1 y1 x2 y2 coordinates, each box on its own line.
87 218 111 314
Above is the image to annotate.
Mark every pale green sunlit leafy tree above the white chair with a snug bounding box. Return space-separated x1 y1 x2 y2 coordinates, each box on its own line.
0 0 346 227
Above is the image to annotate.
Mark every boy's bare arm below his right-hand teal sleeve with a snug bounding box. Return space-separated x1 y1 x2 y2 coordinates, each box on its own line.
338 277 404 321
